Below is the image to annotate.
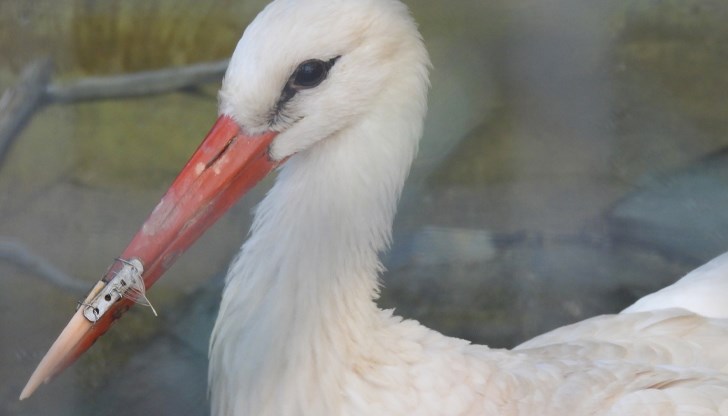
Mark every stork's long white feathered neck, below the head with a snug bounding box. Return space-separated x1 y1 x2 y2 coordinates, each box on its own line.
210 70 426 415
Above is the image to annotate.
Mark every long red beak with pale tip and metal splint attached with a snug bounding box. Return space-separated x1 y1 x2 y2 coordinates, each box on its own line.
20 115 279 400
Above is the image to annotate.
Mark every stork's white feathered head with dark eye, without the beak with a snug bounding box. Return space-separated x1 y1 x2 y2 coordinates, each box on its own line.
220 0 429 160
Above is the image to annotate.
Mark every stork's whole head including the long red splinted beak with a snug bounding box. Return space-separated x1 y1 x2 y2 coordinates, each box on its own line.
21 0 429 399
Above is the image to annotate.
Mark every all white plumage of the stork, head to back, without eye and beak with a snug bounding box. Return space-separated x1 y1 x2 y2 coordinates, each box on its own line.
209 0 728 416
